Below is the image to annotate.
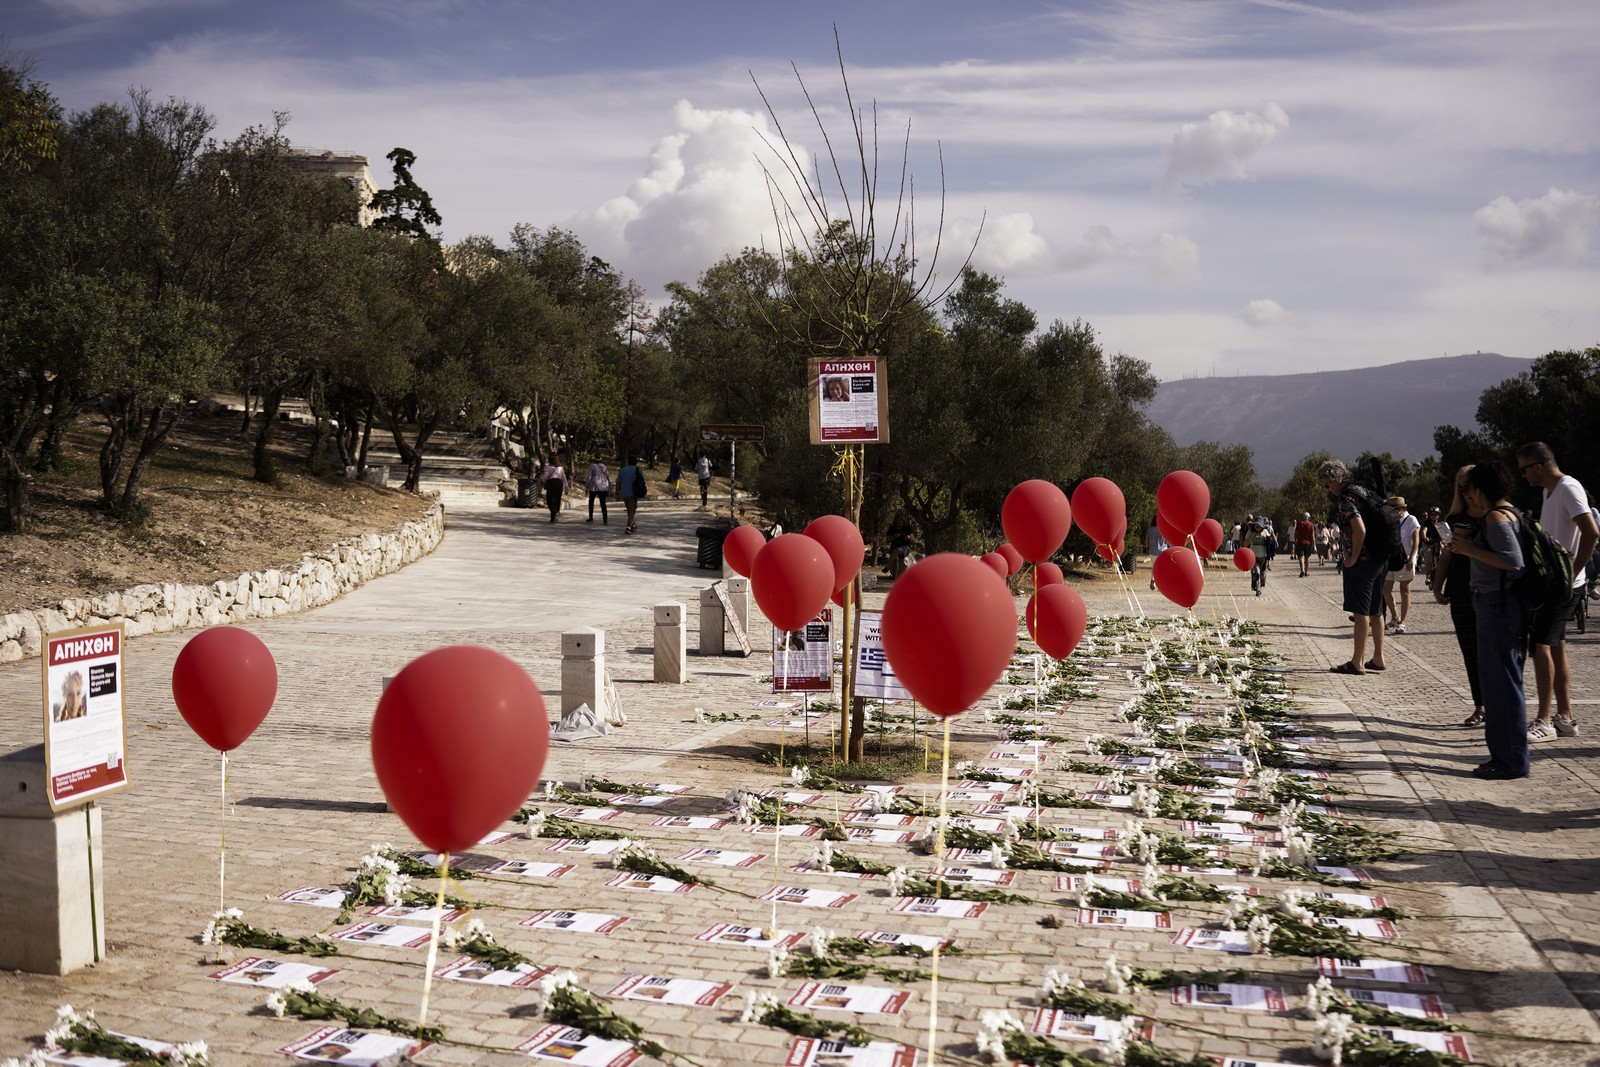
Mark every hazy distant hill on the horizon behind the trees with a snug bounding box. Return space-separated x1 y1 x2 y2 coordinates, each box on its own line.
1147 352 1533 486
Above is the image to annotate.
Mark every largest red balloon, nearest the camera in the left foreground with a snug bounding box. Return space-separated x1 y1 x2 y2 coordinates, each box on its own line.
373 645 550 853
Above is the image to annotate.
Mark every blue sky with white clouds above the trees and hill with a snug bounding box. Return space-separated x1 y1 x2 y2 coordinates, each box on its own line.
12 0 1600 378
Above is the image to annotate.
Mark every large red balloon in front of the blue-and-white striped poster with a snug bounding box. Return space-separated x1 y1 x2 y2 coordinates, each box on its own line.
883 552 1016 715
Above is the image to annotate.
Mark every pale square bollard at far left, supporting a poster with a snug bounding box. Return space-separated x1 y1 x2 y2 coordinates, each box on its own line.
0 744 106 974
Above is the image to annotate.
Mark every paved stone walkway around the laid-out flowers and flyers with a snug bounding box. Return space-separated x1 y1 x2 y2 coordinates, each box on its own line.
0 502 1600 1067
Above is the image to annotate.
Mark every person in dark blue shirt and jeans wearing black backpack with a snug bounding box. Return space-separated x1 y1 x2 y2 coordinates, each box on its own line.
1451 459 1528 781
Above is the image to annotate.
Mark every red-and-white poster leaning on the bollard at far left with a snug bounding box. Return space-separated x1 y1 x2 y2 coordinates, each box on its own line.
42 625 128 811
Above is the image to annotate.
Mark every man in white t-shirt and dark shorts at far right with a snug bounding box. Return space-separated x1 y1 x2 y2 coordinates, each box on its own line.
1517 442 1600 741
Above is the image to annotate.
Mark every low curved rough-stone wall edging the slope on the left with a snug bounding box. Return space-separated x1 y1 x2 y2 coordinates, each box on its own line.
0 504 445 664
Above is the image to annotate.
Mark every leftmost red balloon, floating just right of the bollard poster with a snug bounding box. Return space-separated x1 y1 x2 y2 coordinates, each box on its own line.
173 625 278 752
